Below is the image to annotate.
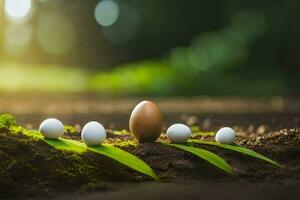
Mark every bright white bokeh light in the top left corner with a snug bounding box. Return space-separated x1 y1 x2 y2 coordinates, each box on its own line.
4 0 32 21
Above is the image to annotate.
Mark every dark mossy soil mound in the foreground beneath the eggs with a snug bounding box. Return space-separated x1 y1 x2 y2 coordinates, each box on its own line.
0 128 300 198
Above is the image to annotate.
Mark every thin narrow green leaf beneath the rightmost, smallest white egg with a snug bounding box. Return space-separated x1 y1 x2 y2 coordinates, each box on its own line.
189 140 282 167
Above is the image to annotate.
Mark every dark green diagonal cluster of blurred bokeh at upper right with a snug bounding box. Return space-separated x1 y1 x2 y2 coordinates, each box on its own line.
170 10 265 75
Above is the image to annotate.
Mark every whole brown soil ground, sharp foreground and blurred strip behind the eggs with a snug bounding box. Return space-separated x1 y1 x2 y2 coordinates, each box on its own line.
0 96 300 199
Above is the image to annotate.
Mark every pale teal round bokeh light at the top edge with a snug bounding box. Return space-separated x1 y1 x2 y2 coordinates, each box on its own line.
94 0 119 26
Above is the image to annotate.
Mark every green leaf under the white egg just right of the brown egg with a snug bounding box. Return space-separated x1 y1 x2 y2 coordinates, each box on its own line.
165 144 232 174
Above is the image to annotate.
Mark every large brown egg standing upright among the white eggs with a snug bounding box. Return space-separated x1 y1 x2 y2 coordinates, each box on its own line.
129 101 163 143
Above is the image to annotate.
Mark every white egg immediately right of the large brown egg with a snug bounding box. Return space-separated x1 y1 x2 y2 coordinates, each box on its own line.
167 124 192 143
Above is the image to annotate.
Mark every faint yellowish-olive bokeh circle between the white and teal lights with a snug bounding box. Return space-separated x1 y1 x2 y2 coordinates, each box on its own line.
37 12 76 55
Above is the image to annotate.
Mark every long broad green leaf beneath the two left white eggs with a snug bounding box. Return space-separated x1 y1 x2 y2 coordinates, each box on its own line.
24 130 159 180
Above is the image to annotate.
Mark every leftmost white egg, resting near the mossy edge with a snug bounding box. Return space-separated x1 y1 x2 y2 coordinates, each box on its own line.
39 118 64 139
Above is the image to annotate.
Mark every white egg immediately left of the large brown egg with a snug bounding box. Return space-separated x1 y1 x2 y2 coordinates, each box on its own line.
81 121 106 146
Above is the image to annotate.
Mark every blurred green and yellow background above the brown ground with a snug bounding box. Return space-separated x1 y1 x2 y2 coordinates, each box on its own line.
0 0 300 96
